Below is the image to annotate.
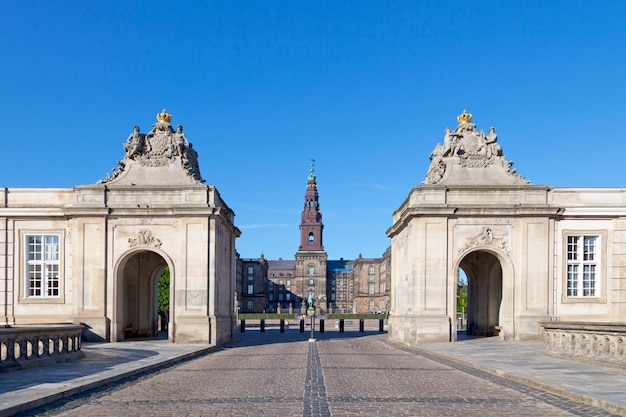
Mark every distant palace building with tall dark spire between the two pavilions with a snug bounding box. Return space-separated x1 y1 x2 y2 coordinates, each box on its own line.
236 161 391 315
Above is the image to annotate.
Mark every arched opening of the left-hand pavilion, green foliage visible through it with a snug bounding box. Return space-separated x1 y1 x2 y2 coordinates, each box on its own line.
119 251 170 340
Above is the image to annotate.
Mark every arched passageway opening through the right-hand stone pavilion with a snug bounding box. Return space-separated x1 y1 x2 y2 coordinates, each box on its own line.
459 251 502 336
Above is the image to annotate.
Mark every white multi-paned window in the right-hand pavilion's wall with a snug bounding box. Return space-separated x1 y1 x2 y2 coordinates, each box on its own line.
566 236 600 297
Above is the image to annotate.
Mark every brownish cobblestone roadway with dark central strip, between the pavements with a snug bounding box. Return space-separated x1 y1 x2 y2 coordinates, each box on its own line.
22 331 611 417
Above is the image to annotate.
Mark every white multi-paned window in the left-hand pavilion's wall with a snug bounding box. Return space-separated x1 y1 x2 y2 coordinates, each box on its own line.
25 235 61 297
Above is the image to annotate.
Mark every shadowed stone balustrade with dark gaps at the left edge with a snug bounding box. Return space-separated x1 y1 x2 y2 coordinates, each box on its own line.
0 324 84 371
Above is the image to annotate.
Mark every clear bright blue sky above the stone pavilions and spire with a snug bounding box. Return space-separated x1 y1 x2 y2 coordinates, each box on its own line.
0 0 626 259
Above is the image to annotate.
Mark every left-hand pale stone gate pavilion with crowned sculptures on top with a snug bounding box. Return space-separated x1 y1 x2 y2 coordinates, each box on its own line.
0 110 240 345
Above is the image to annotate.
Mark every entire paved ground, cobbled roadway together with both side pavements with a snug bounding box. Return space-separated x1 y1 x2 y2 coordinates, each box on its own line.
0 329 626 417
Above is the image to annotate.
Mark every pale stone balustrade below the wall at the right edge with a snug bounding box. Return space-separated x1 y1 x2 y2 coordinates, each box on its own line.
541 321 626 366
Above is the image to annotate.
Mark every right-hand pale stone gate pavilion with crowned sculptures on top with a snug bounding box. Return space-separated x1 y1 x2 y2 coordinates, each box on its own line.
387 111 626 344
